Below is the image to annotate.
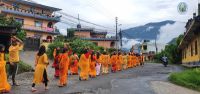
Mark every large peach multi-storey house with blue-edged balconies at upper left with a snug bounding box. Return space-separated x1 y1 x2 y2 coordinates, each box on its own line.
0 0 61 48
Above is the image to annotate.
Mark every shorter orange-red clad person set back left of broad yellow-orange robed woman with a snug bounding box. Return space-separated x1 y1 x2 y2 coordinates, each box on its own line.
69 52 79 75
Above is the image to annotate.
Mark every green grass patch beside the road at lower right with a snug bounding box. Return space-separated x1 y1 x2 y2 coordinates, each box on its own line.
169 68 200 91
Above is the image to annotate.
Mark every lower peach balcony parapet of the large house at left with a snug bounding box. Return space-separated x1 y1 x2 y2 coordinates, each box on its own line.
22 25 57 34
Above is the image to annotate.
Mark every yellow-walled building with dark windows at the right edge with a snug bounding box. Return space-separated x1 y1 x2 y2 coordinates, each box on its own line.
179 5 200 66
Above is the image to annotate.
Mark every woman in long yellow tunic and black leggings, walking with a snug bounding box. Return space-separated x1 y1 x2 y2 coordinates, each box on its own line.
32 45 49 92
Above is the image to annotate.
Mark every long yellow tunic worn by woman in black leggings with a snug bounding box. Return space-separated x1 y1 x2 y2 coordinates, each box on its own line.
33 54 49 84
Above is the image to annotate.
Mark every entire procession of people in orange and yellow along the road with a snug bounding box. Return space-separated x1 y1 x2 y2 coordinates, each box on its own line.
0 37 144 93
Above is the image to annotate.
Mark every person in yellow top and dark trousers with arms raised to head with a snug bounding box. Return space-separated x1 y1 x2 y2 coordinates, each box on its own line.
8 36 23 86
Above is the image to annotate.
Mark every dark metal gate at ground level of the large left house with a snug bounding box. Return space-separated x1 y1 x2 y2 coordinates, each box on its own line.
24 38 40 51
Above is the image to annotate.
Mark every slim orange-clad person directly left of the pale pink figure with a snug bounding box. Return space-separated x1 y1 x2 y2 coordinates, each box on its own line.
89 52 97 78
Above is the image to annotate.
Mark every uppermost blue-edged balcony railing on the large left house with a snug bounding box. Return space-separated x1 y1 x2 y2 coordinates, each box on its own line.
0 6 61 22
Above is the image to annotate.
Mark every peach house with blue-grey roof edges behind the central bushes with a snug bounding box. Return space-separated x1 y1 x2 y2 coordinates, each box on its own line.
73 26 118 48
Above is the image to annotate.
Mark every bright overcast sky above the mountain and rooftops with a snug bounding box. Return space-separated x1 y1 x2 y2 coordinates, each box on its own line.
33 0 198 27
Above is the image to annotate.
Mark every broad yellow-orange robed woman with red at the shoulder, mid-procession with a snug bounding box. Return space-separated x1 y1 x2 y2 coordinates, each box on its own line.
78 49 91 80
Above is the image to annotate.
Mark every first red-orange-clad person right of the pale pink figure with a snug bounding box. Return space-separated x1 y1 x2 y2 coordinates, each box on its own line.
110 52 118 72
